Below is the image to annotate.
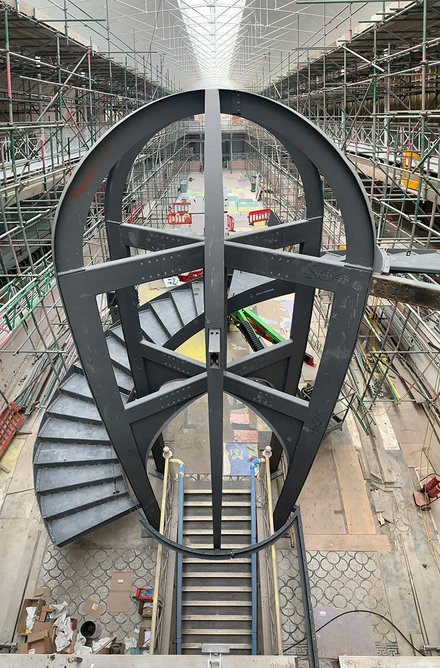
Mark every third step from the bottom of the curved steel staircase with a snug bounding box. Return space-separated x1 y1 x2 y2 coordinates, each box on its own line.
35 463 122 493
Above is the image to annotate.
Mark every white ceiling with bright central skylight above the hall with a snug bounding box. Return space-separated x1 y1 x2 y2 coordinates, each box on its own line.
36 0 383 91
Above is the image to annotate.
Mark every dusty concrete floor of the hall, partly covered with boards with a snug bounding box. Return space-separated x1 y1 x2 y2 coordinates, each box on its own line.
0 174 440 665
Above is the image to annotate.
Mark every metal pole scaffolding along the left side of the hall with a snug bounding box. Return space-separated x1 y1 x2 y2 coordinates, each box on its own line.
0 2 188 411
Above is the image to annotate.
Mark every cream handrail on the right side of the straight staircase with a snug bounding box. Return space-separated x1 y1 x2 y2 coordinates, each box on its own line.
260 445 283 655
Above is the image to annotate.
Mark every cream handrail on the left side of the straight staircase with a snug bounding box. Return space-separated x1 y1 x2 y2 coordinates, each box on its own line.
150 446 181 655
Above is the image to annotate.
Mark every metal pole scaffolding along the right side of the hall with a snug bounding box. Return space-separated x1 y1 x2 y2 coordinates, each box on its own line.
242 0 440 431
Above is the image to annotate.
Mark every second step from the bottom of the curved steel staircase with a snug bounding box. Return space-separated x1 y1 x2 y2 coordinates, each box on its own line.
39 478 127 520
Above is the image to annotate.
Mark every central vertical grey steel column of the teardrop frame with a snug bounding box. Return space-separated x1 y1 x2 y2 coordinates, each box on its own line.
205 90 226 548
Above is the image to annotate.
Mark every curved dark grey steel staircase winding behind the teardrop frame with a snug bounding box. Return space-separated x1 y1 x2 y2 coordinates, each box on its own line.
33 272 292 546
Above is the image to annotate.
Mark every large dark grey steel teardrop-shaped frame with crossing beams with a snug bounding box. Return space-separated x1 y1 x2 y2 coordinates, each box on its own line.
53 89 376 559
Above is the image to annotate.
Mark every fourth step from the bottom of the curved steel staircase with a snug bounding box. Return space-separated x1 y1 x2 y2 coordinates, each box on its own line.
34 441 118 466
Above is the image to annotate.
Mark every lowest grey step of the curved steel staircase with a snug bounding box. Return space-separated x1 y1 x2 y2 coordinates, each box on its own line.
47 495 136 546
